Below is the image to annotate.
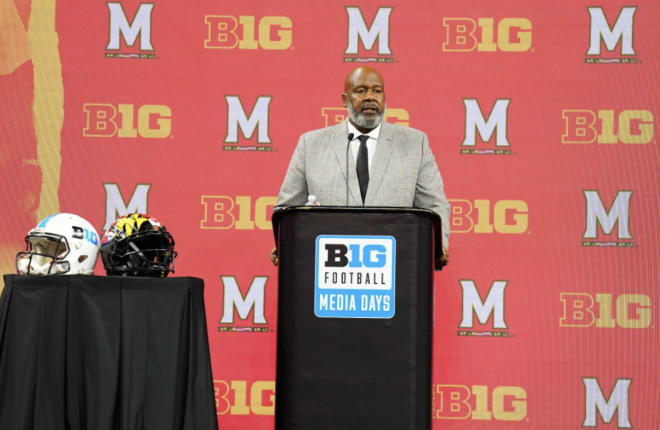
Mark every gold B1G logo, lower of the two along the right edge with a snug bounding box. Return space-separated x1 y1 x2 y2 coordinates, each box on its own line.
559 292 653 329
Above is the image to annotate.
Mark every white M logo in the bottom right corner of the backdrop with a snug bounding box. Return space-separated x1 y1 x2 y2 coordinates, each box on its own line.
582 377 633 429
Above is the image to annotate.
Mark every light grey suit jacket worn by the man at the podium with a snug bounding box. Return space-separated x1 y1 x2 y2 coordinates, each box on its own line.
275 122 449 247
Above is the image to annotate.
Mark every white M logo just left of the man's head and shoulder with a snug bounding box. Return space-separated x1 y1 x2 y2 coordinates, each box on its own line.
222 95 273 151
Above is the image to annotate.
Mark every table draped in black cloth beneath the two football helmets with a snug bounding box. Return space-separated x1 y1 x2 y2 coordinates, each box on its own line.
0 275 218 430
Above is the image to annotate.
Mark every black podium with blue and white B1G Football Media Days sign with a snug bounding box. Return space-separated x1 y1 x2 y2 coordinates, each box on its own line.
273 207 442 430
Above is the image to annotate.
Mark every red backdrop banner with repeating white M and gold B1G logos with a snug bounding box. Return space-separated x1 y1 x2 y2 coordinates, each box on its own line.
0 0 660 430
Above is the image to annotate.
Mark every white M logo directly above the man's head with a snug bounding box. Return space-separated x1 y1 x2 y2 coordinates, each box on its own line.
344 6 394 63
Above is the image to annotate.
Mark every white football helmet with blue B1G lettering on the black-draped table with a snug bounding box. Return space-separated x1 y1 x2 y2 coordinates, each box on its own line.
16 213 100 275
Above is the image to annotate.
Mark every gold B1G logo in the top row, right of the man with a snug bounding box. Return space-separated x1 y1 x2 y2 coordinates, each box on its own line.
442 17 532 52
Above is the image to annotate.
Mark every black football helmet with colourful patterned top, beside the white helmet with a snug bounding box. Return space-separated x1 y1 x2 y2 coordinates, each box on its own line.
101 213 177 278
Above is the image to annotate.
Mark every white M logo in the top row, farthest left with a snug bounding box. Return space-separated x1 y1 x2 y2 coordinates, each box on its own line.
105 2 156 59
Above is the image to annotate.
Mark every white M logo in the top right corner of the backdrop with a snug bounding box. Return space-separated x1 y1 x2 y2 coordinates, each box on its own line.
584 6 638 64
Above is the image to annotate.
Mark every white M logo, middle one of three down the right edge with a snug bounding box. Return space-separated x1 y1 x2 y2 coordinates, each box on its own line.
581 190 635 248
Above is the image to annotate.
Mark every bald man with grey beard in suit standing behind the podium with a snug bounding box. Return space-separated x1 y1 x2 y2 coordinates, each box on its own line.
271 67 449 265
